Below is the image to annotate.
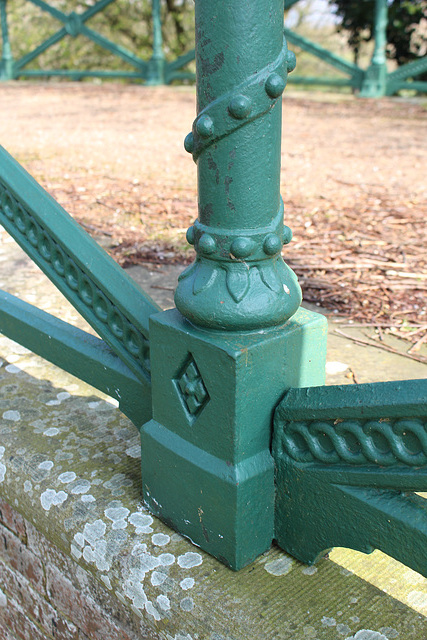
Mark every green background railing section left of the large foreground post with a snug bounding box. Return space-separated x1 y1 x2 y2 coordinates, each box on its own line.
0 0 194 85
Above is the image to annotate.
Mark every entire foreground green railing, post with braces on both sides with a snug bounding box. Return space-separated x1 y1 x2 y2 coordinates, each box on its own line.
0 0 427 577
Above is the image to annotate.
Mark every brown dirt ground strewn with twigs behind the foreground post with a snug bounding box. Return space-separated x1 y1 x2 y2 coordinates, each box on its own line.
0 82 427 360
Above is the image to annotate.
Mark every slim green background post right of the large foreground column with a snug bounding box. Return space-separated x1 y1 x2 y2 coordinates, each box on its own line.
360 0 388 98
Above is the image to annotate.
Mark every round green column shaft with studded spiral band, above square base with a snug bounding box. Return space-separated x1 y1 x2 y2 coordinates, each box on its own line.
175 0 301 331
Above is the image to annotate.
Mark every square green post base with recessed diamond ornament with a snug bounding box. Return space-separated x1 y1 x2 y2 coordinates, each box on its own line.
141 309 326 570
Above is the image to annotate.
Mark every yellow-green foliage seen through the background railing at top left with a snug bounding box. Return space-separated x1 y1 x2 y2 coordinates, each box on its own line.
4 0 194 70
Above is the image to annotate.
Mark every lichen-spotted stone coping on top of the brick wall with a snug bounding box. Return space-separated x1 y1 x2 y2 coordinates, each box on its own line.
0 232 427 640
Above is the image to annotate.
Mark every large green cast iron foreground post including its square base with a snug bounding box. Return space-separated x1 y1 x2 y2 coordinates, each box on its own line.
141 0 326 569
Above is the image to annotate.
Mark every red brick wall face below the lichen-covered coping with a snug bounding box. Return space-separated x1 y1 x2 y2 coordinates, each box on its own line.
0 498 150 640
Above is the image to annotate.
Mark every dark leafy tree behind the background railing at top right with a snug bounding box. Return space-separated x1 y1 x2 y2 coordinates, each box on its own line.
329 0 427 65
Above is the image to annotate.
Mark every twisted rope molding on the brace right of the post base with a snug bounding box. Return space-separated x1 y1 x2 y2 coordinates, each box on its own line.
280 418 427 467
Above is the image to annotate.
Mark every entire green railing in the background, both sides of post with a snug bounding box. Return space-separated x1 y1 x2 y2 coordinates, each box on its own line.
0 0 427 98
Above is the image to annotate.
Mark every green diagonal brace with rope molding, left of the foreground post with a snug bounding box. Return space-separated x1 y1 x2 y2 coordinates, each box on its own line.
0 147 159 380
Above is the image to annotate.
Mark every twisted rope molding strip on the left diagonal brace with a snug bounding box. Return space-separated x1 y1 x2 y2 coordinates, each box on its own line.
0 182 150 376
